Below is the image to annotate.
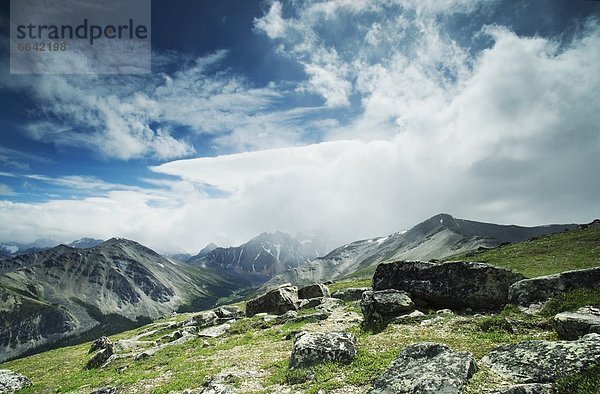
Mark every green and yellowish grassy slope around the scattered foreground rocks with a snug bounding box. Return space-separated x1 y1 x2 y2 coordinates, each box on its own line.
0 225 600 394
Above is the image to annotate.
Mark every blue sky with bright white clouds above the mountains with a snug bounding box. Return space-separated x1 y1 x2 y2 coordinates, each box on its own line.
0 0 600 253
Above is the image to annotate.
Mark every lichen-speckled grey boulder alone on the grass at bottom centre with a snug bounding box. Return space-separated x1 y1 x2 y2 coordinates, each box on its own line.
290 332 356 369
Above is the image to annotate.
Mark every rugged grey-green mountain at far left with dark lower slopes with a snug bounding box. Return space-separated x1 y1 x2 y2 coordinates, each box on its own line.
0 238 248 361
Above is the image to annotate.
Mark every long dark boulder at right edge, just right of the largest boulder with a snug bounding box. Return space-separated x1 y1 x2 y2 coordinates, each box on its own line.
508 267 600 306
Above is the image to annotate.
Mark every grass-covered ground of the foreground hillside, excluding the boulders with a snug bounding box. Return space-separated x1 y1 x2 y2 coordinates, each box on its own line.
0 223 600 394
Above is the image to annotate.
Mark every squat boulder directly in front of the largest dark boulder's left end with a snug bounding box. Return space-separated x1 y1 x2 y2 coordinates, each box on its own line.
360 289 415 324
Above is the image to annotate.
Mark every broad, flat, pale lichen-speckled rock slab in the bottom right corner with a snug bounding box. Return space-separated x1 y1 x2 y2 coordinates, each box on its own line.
481 334 600 383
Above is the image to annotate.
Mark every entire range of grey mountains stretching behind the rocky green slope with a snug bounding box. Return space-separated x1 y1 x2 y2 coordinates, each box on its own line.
0 214 574 361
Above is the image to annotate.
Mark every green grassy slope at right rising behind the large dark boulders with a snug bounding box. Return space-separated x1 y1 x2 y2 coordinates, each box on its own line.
452 224 600 278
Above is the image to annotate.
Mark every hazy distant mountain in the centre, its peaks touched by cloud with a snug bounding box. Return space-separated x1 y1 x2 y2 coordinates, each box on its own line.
187 232 327 283
